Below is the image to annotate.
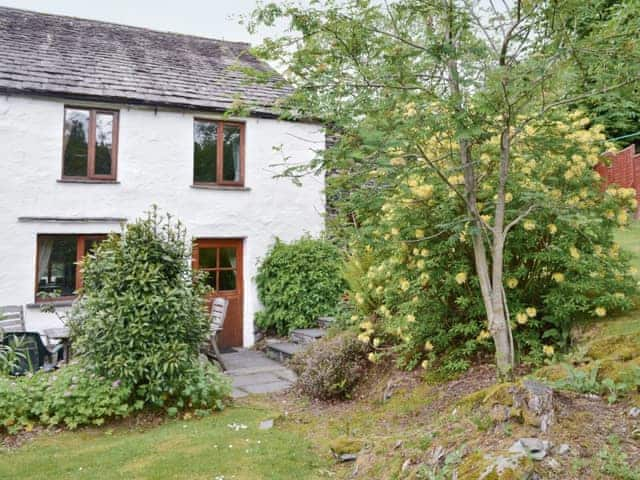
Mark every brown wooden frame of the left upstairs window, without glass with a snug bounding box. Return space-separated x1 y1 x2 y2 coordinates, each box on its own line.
60 105 120 183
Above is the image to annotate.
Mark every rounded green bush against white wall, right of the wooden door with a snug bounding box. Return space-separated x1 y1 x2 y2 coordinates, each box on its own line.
256 237 344 335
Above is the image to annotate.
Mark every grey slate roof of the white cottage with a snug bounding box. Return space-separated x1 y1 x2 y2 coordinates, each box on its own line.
0 7 291 116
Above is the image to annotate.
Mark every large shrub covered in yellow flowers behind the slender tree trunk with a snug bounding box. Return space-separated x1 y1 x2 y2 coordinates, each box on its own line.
334 112 636 373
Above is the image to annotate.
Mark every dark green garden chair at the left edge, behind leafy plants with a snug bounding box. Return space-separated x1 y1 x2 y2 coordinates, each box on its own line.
2 332 63 375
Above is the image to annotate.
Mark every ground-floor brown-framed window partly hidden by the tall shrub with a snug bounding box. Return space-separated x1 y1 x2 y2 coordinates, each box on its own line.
36 234 107 300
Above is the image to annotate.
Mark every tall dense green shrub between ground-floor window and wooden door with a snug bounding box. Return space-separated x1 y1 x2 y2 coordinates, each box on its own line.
71 209 230 408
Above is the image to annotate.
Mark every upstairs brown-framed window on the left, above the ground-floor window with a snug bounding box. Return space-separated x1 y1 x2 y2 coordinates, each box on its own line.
62 107 118 181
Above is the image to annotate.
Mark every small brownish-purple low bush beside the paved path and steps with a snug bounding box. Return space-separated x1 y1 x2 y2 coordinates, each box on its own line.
290 332 368 400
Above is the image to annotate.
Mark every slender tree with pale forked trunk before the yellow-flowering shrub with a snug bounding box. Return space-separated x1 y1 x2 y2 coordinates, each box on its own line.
245 0 639 377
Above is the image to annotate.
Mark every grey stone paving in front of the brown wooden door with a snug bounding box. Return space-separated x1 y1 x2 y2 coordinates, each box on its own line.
222 349 296 398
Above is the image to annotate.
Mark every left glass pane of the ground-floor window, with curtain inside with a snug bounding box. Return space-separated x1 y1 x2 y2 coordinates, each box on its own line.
38 235 78 296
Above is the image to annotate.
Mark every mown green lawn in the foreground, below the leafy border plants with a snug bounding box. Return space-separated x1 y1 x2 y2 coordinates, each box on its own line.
0 406 327 480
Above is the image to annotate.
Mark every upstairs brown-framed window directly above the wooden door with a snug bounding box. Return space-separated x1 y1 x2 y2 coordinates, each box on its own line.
193 120 244 187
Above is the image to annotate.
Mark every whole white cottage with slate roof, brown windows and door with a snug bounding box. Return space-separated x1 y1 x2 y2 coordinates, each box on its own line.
0 7 324 346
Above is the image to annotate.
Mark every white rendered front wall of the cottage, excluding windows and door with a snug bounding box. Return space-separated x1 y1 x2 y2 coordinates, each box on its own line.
0 96 324 346
